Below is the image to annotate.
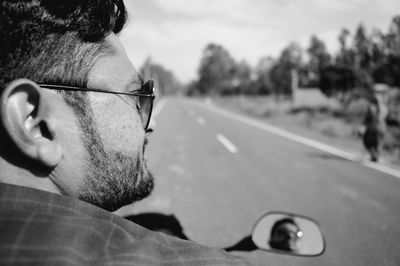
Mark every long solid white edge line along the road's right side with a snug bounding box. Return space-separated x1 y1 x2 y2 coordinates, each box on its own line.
194 102 400 178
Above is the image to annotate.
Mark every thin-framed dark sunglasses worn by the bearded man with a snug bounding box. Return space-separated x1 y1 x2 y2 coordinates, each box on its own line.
38 80 155 130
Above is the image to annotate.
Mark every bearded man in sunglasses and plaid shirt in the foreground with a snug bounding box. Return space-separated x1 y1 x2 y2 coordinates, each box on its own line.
0 0 253 265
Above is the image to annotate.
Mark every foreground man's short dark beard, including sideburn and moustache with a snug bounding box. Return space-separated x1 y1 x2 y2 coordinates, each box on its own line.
72 98 154 211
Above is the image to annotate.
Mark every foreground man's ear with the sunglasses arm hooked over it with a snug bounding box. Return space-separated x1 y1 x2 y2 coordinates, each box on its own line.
0 79 63 167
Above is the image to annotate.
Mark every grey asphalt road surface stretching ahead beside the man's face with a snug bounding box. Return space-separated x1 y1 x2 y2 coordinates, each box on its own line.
117 98 400 266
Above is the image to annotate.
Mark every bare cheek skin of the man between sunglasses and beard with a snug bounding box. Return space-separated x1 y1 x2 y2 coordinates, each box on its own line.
93 95 144 152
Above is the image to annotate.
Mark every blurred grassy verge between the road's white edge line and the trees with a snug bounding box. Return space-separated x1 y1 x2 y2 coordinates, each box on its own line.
209 96 400 166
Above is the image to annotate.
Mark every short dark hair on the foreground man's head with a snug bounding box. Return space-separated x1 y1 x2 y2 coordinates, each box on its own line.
0 0 127 90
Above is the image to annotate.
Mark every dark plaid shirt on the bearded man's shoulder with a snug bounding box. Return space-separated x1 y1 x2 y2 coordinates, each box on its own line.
0 183 255 266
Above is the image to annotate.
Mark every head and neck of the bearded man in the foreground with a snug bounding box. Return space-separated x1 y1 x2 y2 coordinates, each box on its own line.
0 0 153 210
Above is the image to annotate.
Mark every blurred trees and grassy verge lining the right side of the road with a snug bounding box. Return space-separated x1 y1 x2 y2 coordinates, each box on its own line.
141 15 400 165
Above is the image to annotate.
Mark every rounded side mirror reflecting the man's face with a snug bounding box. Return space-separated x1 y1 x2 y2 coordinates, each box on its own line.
251 212 325 256
